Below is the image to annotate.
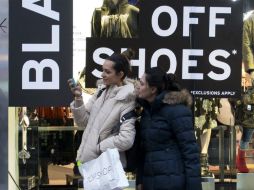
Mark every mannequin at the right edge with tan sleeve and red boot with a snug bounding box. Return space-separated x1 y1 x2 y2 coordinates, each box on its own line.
236 10 254 173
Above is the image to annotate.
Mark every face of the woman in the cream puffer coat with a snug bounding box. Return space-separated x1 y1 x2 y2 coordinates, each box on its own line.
101 60 123 86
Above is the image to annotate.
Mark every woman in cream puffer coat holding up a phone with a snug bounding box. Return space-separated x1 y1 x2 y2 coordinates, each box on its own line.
68 49 135 167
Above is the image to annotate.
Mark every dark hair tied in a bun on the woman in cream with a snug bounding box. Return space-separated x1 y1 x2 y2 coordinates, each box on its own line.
106 49 134 79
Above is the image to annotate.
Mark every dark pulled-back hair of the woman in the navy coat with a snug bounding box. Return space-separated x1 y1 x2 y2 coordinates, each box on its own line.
145 67 182 94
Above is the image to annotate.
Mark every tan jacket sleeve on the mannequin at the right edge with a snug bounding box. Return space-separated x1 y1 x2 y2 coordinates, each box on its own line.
242 12 254 73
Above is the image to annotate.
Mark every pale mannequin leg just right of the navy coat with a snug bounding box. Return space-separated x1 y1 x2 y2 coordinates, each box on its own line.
200 129 212 176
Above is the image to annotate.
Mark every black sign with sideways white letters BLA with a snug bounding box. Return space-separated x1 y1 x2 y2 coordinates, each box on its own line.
9 0 73 106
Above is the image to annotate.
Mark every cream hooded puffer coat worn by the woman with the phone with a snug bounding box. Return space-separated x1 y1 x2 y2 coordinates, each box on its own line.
71 81 135 166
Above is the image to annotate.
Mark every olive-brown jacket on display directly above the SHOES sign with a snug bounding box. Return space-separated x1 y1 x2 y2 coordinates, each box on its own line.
92 0 139 38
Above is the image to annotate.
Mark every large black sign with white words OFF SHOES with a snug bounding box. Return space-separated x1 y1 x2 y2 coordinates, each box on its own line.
86 0 243 97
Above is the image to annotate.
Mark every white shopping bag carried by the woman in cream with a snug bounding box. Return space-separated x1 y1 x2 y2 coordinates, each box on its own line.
79 148 129 190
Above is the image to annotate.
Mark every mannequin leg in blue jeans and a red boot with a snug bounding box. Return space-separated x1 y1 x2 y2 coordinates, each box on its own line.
236 127 254 173
